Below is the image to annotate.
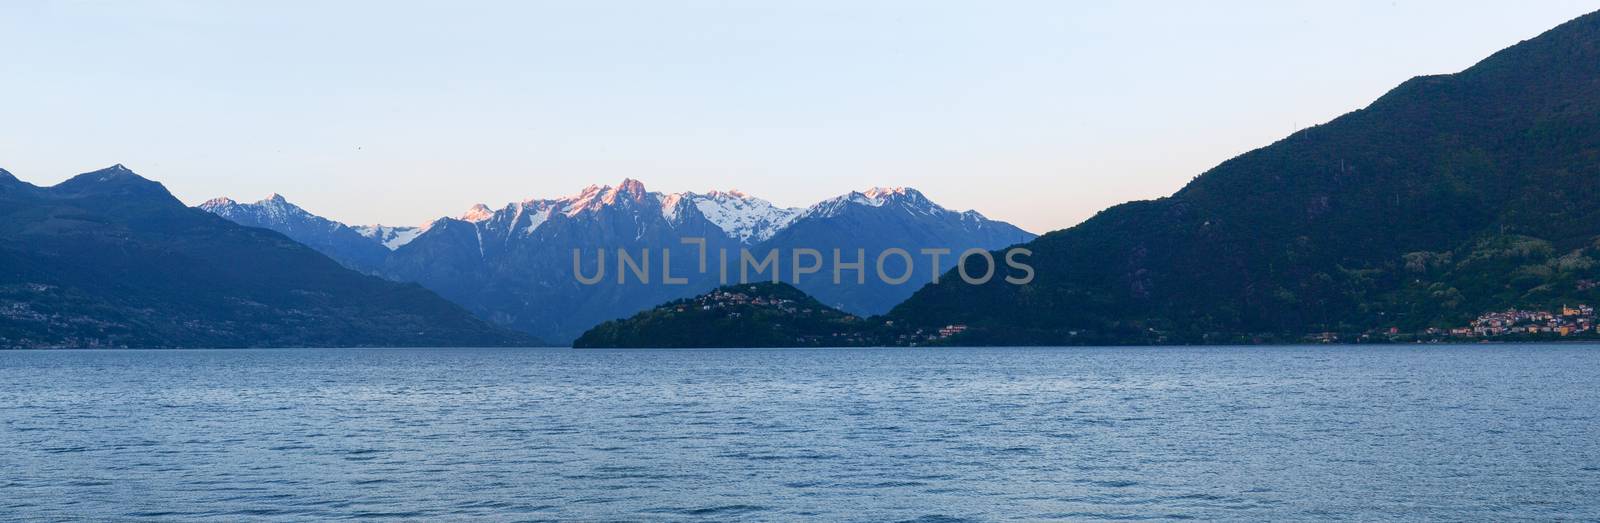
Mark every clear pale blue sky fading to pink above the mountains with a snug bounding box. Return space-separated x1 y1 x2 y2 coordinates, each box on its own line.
0 0 1600 232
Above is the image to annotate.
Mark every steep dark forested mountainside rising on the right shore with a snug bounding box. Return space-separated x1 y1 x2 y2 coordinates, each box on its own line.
893 14 1600 344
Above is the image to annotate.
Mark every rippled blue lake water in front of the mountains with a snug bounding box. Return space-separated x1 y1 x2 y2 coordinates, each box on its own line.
0 345 1600 521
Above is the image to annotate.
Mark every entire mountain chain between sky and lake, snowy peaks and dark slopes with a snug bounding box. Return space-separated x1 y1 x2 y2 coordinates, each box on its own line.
25 13 1600 347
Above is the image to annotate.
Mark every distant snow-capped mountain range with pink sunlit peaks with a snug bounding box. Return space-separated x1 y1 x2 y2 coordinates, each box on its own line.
200 179 1034 341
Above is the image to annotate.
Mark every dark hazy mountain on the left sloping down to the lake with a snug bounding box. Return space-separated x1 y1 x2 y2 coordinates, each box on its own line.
0 165 533 347
